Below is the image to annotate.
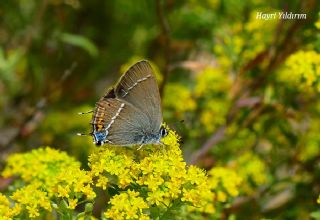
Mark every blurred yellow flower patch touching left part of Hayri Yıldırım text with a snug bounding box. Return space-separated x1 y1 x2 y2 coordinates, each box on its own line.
214 9 278 70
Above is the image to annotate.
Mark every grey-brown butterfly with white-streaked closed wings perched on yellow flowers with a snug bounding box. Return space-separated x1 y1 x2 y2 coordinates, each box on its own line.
79 60 167 147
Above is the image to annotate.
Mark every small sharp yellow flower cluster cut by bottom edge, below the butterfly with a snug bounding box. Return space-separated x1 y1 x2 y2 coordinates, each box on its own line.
104 190 150 220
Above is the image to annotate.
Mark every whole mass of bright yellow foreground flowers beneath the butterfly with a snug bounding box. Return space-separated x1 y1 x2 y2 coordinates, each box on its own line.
0 129 240 219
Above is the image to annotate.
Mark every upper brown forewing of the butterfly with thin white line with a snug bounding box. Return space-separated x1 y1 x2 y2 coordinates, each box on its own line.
114 61 162 134
